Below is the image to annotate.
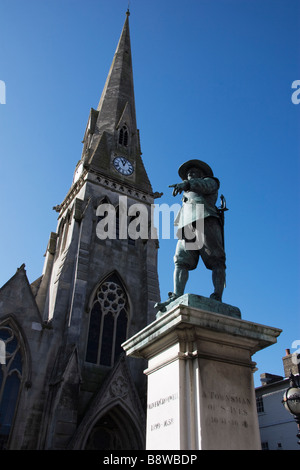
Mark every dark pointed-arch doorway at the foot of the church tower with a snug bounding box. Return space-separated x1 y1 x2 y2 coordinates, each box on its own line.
84 405 144 450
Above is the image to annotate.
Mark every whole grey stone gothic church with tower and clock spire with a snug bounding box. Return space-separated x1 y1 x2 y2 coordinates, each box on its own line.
0 12 159 450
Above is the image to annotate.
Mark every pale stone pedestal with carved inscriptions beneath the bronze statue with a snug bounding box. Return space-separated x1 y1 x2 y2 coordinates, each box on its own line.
123 294 281 450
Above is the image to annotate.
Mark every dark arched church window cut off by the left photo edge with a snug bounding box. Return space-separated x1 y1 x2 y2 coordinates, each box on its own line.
0 325 22 449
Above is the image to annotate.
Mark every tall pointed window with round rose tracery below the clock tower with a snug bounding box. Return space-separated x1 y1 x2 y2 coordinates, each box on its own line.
85 274 128 366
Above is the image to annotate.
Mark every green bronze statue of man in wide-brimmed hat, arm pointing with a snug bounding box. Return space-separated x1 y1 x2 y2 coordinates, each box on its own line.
156 160 227 308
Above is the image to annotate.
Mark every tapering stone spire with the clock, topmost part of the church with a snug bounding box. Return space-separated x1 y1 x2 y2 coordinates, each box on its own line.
82 9 152 193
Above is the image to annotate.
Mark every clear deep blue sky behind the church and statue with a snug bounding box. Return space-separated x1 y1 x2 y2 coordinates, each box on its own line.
0 0 300 385
